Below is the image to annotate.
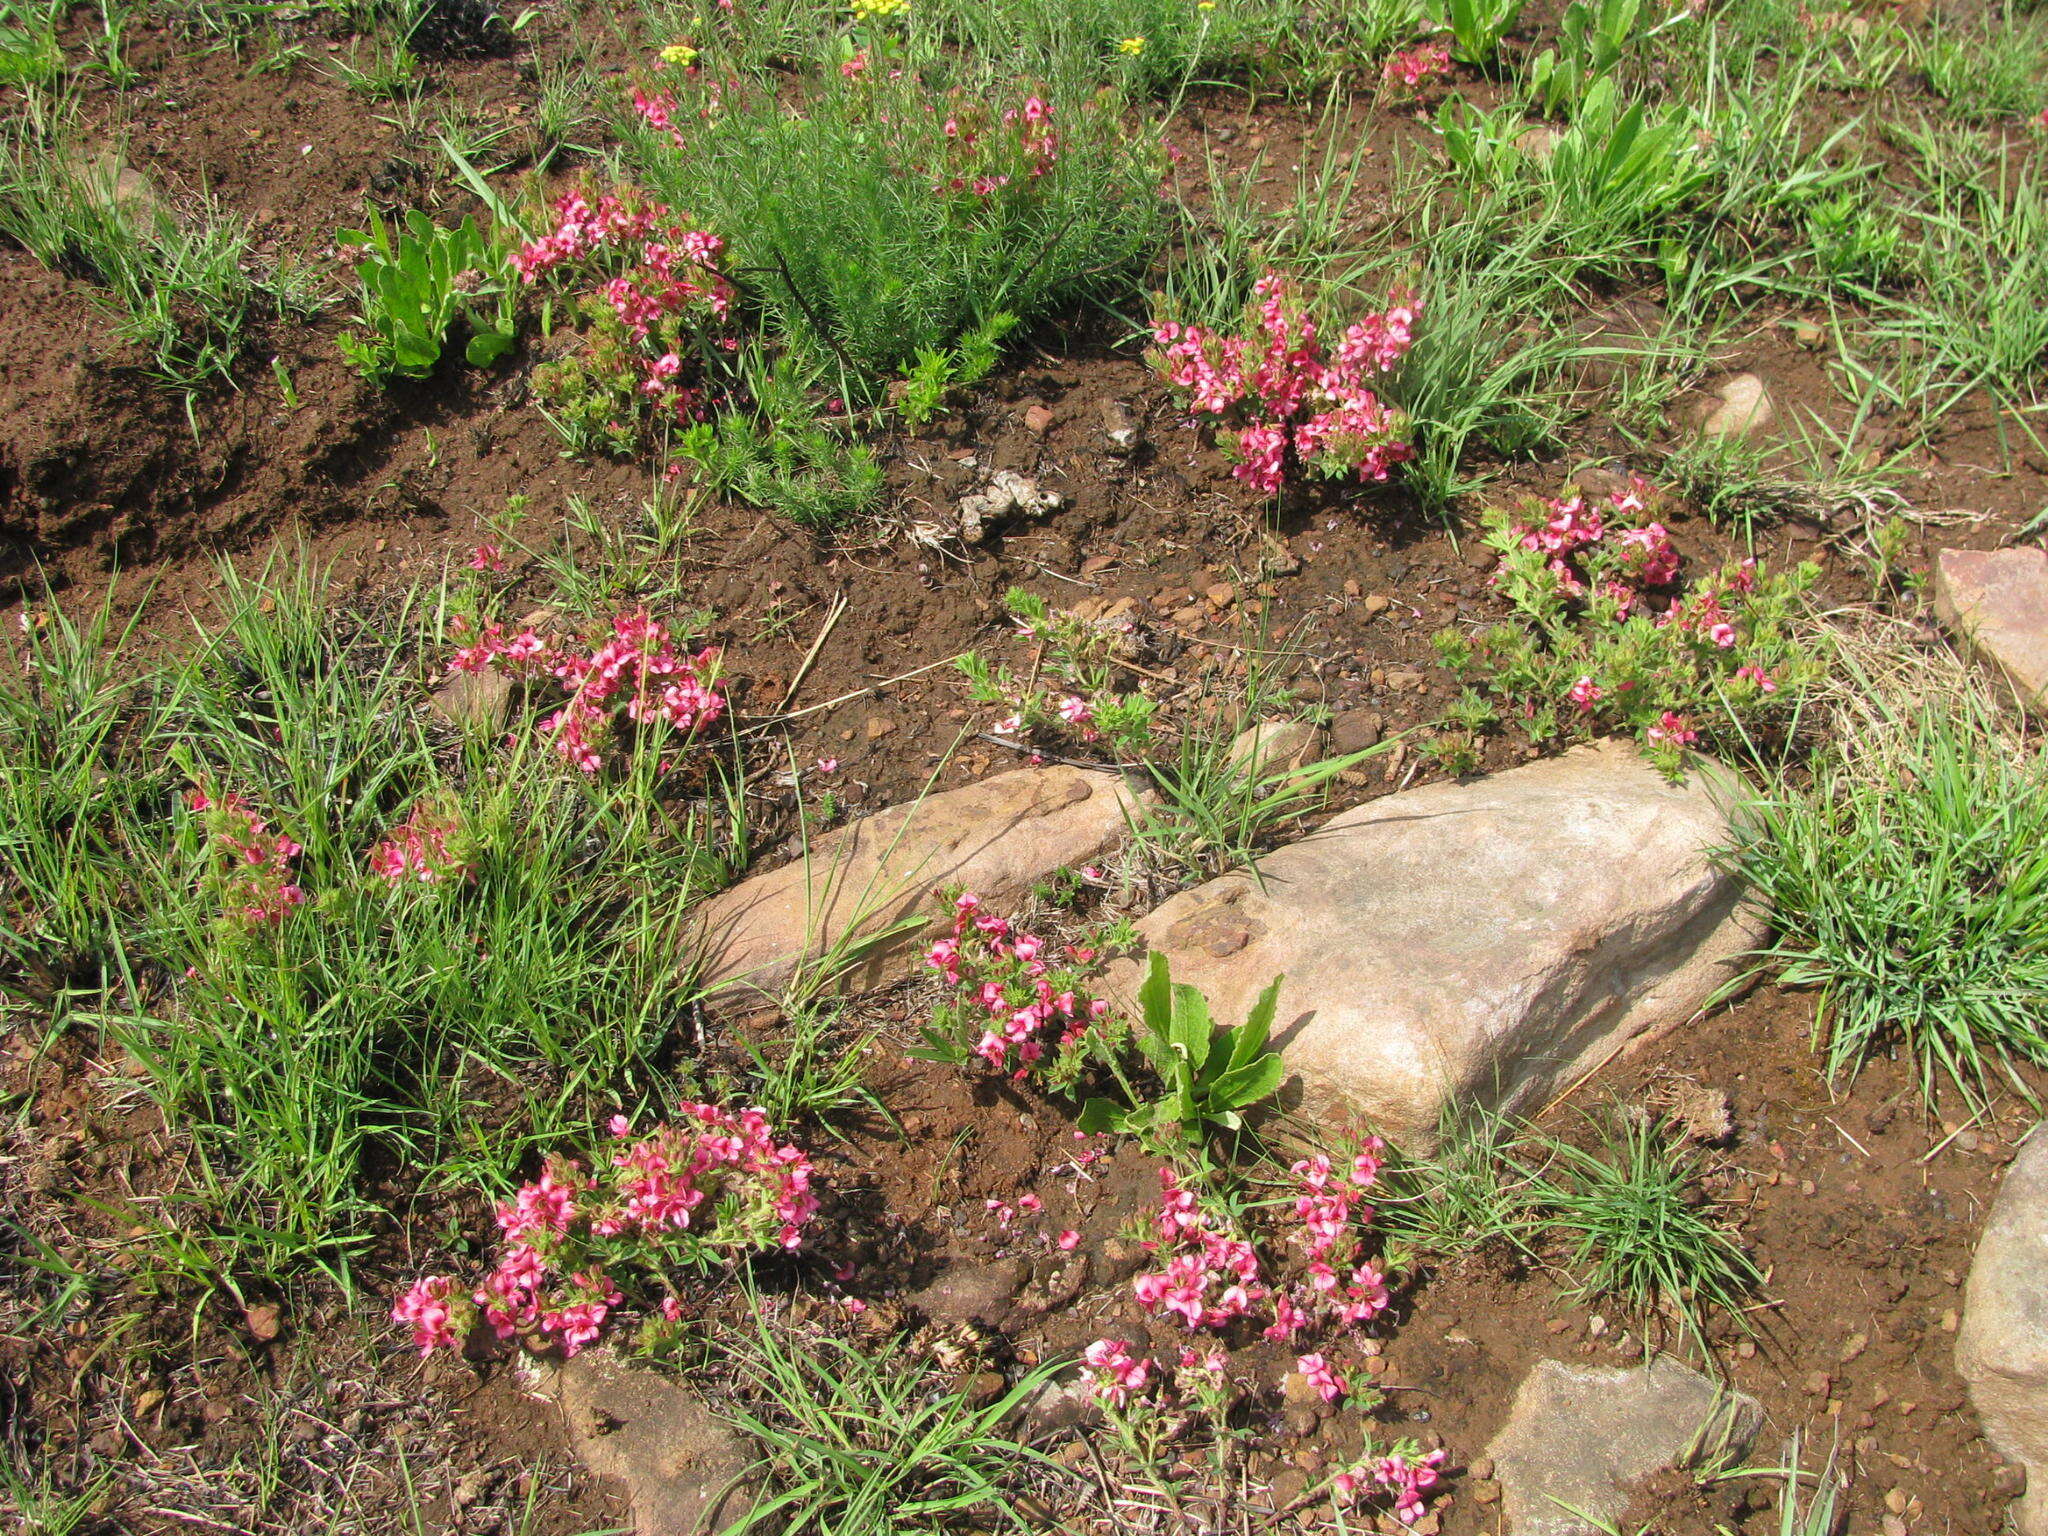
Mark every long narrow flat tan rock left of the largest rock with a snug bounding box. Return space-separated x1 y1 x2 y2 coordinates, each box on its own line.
690 766 1139 1004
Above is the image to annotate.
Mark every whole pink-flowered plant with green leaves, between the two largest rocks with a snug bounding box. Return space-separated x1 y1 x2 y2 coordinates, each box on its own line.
911 891 1110 1087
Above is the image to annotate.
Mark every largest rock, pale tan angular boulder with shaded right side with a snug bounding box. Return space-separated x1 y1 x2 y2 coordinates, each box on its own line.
1108 741 1763 1141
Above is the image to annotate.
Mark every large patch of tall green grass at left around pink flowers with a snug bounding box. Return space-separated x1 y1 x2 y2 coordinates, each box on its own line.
0 567 757 1280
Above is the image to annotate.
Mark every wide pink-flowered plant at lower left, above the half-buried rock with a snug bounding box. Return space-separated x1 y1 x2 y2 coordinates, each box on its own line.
391 1104 817 1356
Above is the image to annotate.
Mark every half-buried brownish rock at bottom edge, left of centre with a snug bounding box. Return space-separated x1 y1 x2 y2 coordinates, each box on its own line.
541 1350 756 1536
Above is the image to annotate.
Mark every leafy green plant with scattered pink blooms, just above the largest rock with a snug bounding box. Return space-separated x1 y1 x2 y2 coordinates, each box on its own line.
1438 477 1819 772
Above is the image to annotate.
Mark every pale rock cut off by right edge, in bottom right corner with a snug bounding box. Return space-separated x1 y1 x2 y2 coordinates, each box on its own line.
1956 1126 2048 1536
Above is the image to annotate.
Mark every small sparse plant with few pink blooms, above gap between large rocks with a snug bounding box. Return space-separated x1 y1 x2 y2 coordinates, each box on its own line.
956 588 1153 758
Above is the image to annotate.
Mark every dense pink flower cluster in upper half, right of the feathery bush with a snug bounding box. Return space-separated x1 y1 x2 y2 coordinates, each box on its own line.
1153 272 1421 496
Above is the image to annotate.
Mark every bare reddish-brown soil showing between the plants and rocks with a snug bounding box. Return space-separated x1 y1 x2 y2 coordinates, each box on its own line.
0 18 2048 1536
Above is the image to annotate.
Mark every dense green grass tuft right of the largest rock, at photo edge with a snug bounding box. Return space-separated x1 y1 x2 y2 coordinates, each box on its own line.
1741 674 2048 1100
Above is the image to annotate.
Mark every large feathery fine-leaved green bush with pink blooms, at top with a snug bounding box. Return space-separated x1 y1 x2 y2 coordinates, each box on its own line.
623 61 1161 403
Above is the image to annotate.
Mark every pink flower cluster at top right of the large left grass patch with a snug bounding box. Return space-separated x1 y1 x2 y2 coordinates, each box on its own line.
449 608 725 774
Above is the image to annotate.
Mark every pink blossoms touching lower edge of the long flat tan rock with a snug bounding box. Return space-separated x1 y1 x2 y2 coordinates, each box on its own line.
924 891 1110 1079
